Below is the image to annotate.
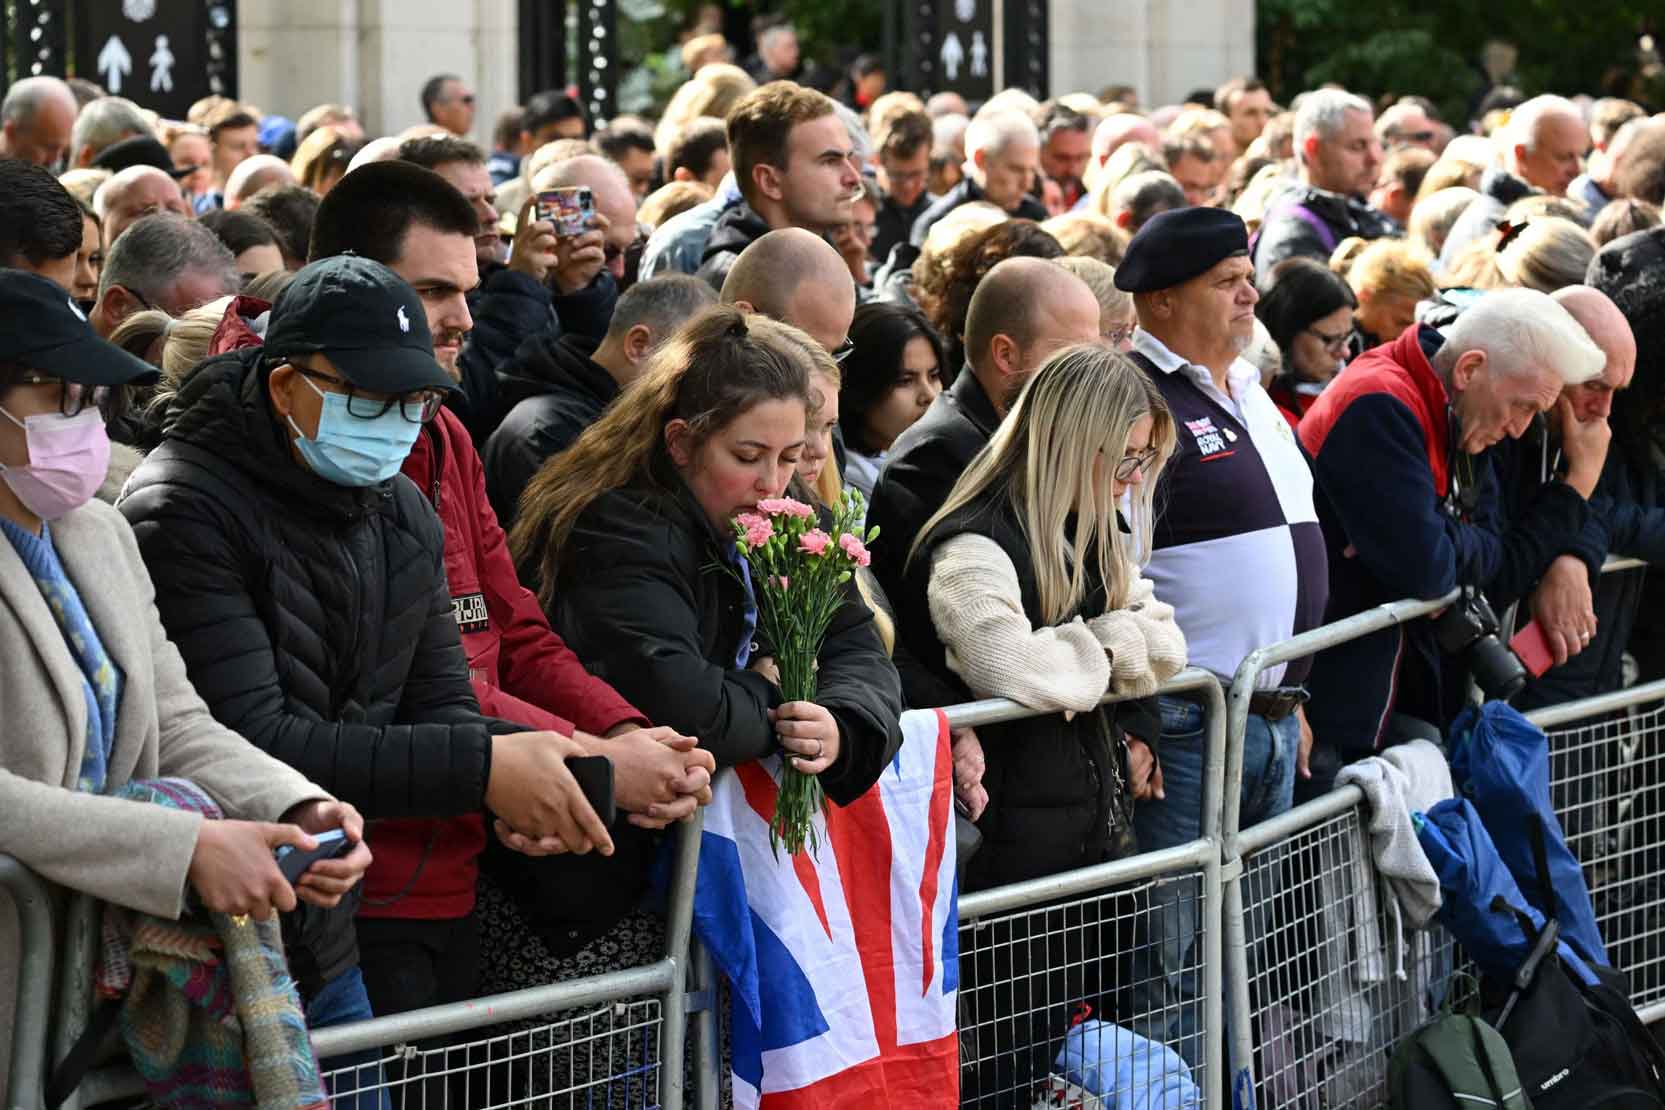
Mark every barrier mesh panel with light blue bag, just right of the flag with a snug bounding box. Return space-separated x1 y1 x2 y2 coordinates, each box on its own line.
959 872 1209 1110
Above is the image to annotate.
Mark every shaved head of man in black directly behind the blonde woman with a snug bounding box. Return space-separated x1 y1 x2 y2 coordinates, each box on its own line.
966 258 1099 414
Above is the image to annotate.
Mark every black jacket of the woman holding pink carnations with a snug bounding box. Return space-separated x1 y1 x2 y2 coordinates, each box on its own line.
549 478 902 805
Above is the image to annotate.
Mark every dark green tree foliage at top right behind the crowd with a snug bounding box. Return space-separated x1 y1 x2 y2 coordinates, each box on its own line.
1255 0 1665 126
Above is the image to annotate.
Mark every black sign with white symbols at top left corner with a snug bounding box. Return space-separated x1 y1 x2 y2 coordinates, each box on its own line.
75 0 236 120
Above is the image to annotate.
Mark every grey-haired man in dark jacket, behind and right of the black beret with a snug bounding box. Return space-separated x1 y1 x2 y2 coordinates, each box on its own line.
1250 88 1399 293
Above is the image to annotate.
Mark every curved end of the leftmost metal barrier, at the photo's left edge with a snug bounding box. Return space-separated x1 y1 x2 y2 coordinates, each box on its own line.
0 854 53 1110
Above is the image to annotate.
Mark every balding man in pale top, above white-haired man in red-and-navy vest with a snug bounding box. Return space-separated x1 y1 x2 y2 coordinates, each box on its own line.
1440 95 1590 266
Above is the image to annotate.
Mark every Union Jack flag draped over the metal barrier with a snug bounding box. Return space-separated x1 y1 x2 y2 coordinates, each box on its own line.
694 709 959 1110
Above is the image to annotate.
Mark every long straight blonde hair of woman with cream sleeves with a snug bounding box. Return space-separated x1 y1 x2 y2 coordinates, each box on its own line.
907 343 1175 624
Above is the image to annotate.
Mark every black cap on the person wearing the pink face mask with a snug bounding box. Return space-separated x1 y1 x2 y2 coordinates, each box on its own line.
0 270 160 386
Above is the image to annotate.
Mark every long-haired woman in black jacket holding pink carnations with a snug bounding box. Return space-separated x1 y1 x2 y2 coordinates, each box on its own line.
509 306 902 815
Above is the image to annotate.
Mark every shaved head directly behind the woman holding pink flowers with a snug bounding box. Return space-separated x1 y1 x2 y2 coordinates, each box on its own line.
723 228 856 351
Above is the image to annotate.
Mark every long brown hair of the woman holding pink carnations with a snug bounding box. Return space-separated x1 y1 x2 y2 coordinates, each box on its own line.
509 305 814 607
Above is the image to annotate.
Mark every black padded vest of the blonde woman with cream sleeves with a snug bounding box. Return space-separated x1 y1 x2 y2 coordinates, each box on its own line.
896 499 1162 890
